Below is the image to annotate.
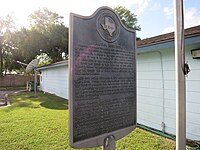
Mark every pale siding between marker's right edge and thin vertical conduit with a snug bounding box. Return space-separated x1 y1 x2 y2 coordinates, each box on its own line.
137 52 164 130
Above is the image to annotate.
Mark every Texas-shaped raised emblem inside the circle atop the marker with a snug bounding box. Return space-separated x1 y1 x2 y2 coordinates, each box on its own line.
101 17 116 36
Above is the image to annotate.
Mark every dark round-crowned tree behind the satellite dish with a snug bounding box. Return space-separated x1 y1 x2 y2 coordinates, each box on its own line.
4 28 48 73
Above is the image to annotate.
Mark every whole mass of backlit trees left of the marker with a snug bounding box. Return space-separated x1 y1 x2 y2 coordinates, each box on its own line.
0 8 68 74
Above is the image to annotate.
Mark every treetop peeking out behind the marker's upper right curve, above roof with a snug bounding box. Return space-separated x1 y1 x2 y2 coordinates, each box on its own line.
114 6 141 31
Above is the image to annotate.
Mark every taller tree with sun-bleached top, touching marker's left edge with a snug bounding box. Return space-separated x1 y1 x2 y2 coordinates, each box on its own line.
29 8 68 62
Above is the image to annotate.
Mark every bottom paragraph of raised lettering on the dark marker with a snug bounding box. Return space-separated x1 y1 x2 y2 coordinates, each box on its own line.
74 96 136 141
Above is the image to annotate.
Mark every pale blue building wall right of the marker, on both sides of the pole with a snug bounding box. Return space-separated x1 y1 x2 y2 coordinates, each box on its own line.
137 42 200 140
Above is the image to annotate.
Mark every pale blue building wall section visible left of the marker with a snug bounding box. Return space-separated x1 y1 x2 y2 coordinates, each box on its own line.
40 65 68 99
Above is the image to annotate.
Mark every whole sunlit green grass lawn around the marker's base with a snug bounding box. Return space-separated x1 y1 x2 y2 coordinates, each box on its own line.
0 92 175 150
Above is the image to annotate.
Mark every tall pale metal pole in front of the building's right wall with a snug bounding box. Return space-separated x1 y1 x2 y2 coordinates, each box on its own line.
174 0 186 150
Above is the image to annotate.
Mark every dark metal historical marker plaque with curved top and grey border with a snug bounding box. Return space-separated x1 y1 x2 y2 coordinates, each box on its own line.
69 7 137 148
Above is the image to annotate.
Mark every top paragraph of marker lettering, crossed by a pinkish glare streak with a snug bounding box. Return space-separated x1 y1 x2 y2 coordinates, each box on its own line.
75 44 135 75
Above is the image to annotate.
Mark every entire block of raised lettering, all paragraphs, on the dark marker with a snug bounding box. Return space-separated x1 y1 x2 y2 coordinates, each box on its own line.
73 43 136 141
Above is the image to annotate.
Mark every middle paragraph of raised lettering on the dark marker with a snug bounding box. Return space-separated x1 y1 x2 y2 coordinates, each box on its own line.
75 77 134 101
